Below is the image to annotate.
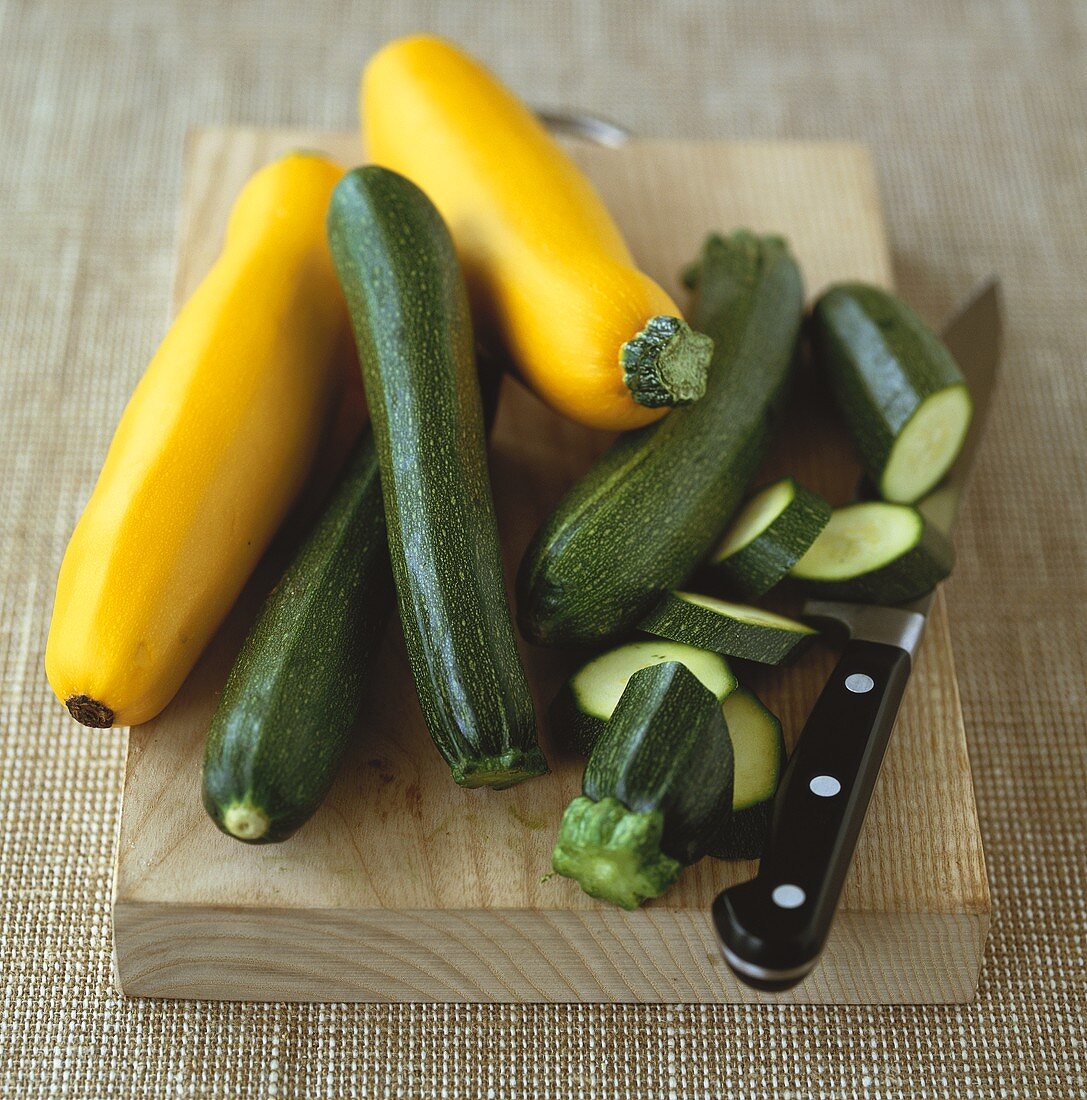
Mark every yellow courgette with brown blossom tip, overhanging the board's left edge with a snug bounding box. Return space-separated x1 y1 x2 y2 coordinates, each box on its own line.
45 153 350 726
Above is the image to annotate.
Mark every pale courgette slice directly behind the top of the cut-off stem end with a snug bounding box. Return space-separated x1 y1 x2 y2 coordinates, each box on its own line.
550 639 737 756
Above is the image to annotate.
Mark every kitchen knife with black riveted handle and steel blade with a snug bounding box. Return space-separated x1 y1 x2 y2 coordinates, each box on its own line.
713 279 1000 992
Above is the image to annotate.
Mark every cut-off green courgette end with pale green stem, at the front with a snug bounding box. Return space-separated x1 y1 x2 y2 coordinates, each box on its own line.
551 661 733 909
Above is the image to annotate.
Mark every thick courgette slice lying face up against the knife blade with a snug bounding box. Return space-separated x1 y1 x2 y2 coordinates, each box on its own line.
792 501 955 604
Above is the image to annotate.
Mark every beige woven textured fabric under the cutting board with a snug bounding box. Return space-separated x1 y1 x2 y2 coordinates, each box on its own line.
0 0 1087 1098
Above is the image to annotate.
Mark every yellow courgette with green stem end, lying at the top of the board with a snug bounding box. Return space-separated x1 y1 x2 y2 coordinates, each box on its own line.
361 35 712 430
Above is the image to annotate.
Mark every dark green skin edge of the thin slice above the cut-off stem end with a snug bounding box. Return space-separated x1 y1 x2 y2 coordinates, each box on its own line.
639 592 816 664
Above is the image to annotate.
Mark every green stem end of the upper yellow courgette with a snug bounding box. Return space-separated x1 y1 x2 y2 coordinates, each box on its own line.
619 317 713 408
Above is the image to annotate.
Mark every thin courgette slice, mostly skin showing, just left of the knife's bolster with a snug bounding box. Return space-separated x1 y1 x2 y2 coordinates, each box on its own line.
639 592 817 664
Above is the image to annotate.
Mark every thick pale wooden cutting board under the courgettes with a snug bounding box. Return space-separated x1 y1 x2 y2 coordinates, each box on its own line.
113 130 989 1003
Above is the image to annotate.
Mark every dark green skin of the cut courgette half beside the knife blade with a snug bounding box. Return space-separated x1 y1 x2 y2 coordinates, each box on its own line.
812 283 966 503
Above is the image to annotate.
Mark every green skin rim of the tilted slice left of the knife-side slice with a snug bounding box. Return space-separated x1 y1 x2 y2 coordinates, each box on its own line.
709 477 831 600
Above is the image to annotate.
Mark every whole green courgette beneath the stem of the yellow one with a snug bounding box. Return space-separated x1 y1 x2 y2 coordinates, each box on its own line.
518 231 803 645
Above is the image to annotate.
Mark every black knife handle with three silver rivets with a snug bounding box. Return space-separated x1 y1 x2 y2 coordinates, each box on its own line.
713 639 910 991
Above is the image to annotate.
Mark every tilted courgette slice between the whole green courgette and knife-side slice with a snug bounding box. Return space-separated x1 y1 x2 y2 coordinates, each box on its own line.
710 477 831 598
